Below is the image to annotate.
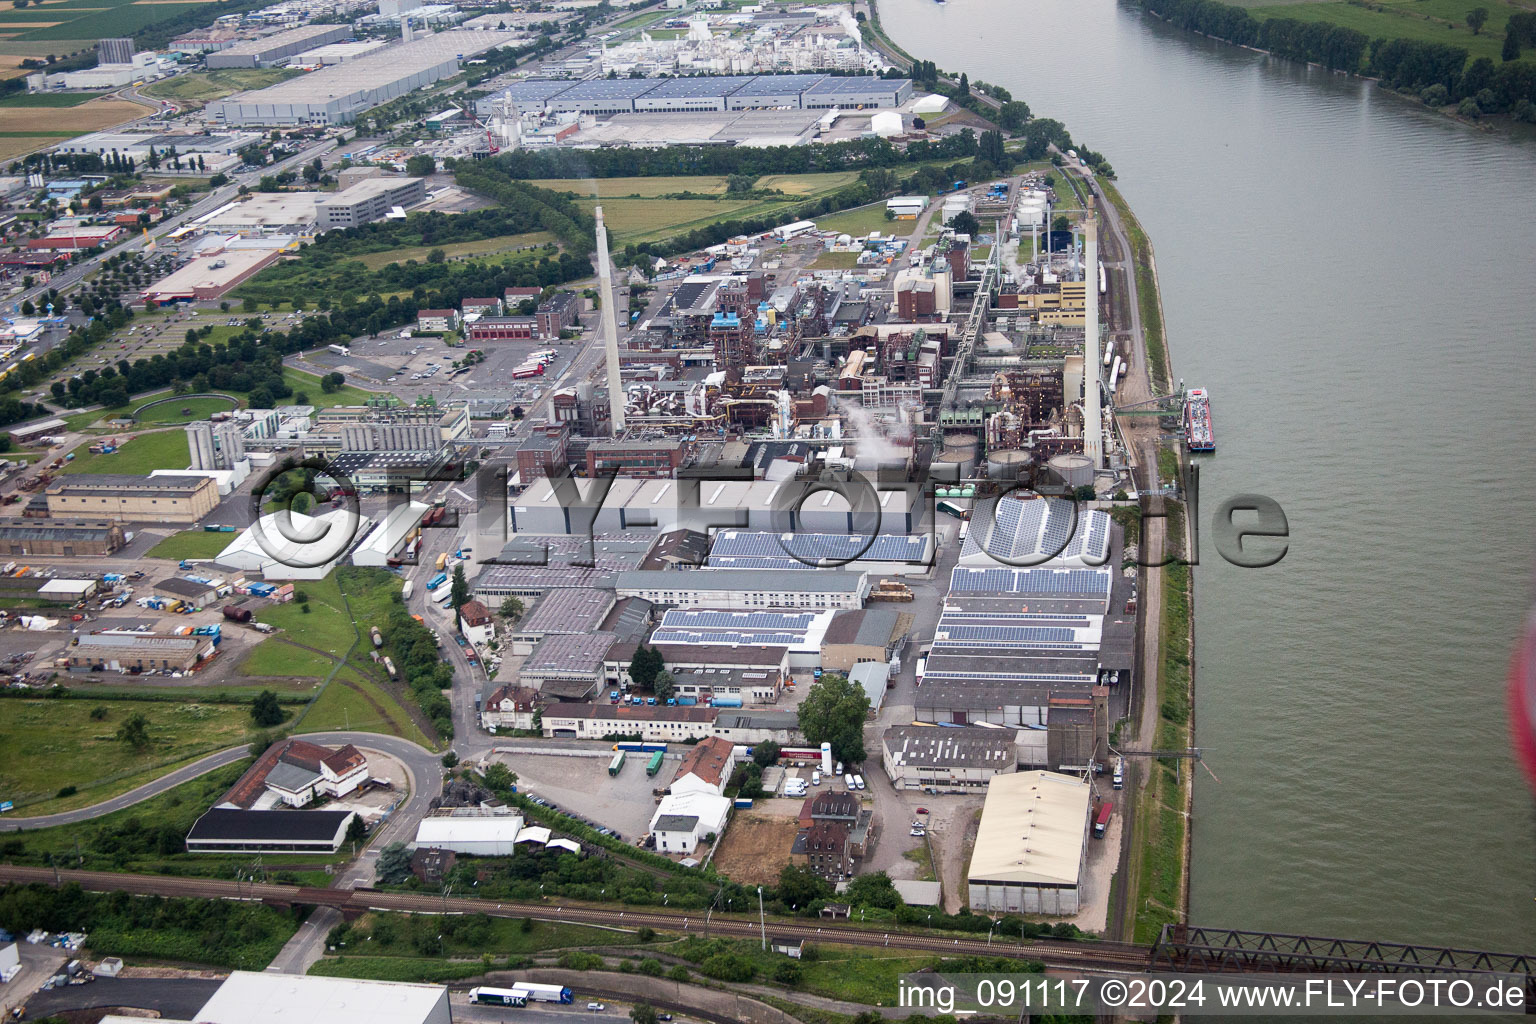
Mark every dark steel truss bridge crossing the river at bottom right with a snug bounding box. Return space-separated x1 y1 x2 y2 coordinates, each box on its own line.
1150 924 1536 978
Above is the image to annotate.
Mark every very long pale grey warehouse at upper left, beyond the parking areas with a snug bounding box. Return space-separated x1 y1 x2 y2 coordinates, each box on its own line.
207 32 516 124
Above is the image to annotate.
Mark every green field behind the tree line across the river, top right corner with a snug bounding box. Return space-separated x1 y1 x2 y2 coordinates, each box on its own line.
1236 0 1531 63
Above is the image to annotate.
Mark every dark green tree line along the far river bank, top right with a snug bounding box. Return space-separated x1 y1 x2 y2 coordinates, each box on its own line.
1141 0 1536 120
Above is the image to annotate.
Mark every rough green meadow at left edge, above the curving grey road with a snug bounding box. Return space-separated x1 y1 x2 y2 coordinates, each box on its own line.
0 694 250 814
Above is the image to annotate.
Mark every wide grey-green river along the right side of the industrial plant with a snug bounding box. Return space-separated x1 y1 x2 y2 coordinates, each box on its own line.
880 0 1536 952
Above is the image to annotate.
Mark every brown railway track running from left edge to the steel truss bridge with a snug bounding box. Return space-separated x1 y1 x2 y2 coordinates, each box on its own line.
0 864 1152 972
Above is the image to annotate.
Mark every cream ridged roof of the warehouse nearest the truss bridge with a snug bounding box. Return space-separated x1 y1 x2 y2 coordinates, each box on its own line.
968 772 1091 886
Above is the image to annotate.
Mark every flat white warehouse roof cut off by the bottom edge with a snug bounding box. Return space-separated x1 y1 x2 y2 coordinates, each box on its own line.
194 970 447 1024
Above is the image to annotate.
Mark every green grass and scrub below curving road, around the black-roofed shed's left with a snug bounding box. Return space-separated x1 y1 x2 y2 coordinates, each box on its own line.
0 758 350 886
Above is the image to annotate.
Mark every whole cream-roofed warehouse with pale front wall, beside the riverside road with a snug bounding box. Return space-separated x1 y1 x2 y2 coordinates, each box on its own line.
966 772 1092 915
